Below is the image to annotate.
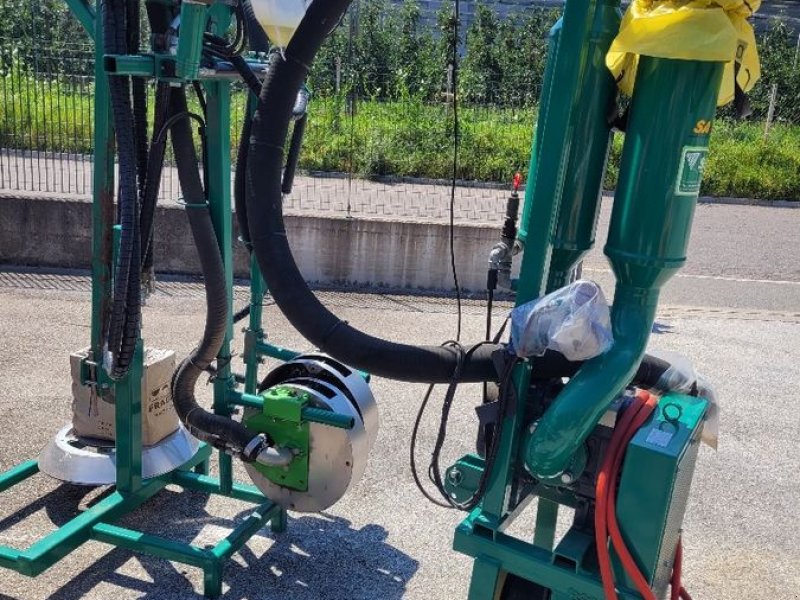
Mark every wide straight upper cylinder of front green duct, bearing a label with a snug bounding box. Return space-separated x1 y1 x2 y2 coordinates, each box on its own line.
605 57 722 287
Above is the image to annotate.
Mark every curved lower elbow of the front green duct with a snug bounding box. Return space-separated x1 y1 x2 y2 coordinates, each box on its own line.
522 285 658 482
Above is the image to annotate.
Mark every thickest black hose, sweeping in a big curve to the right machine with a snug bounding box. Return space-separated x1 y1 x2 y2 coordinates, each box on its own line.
245 0 680 385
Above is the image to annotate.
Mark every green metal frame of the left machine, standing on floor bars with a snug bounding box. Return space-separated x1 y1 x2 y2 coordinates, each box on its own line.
0 0 306 597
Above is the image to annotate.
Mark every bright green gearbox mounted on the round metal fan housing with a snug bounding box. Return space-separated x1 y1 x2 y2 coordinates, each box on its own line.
244 386 311 492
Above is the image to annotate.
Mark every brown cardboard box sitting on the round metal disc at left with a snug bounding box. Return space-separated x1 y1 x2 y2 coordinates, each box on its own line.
70 348 178 446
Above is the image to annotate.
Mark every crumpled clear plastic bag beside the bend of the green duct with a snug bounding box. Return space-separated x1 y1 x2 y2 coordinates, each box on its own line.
511 279 614 361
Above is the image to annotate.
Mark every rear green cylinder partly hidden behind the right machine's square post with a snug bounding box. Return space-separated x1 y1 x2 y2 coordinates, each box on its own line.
547 0 621 292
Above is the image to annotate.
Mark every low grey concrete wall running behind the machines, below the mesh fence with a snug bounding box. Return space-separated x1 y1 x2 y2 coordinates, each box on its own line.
0 196 499 290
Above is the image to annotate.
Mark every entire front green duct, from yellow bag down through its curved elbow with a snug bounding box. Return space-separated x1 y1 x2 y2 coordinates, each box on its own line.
524 56 723 480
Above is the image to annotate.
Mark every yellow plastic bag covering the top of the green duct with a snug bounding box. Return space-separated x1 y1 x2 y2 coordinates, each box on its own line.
606 0 761 106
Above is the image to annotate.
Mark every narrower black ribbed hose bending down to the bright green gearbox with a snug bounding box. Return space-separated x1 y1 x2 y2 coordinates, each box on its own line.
171 88 259 460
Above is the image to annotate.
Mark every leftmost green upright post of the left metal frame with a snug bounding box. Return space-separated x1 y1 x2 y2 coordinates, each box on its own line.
91 4 114 362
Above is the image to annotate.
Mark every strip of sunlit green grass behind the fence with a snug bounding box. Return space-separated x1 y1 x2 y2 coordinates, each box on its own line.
0 69 800 200
